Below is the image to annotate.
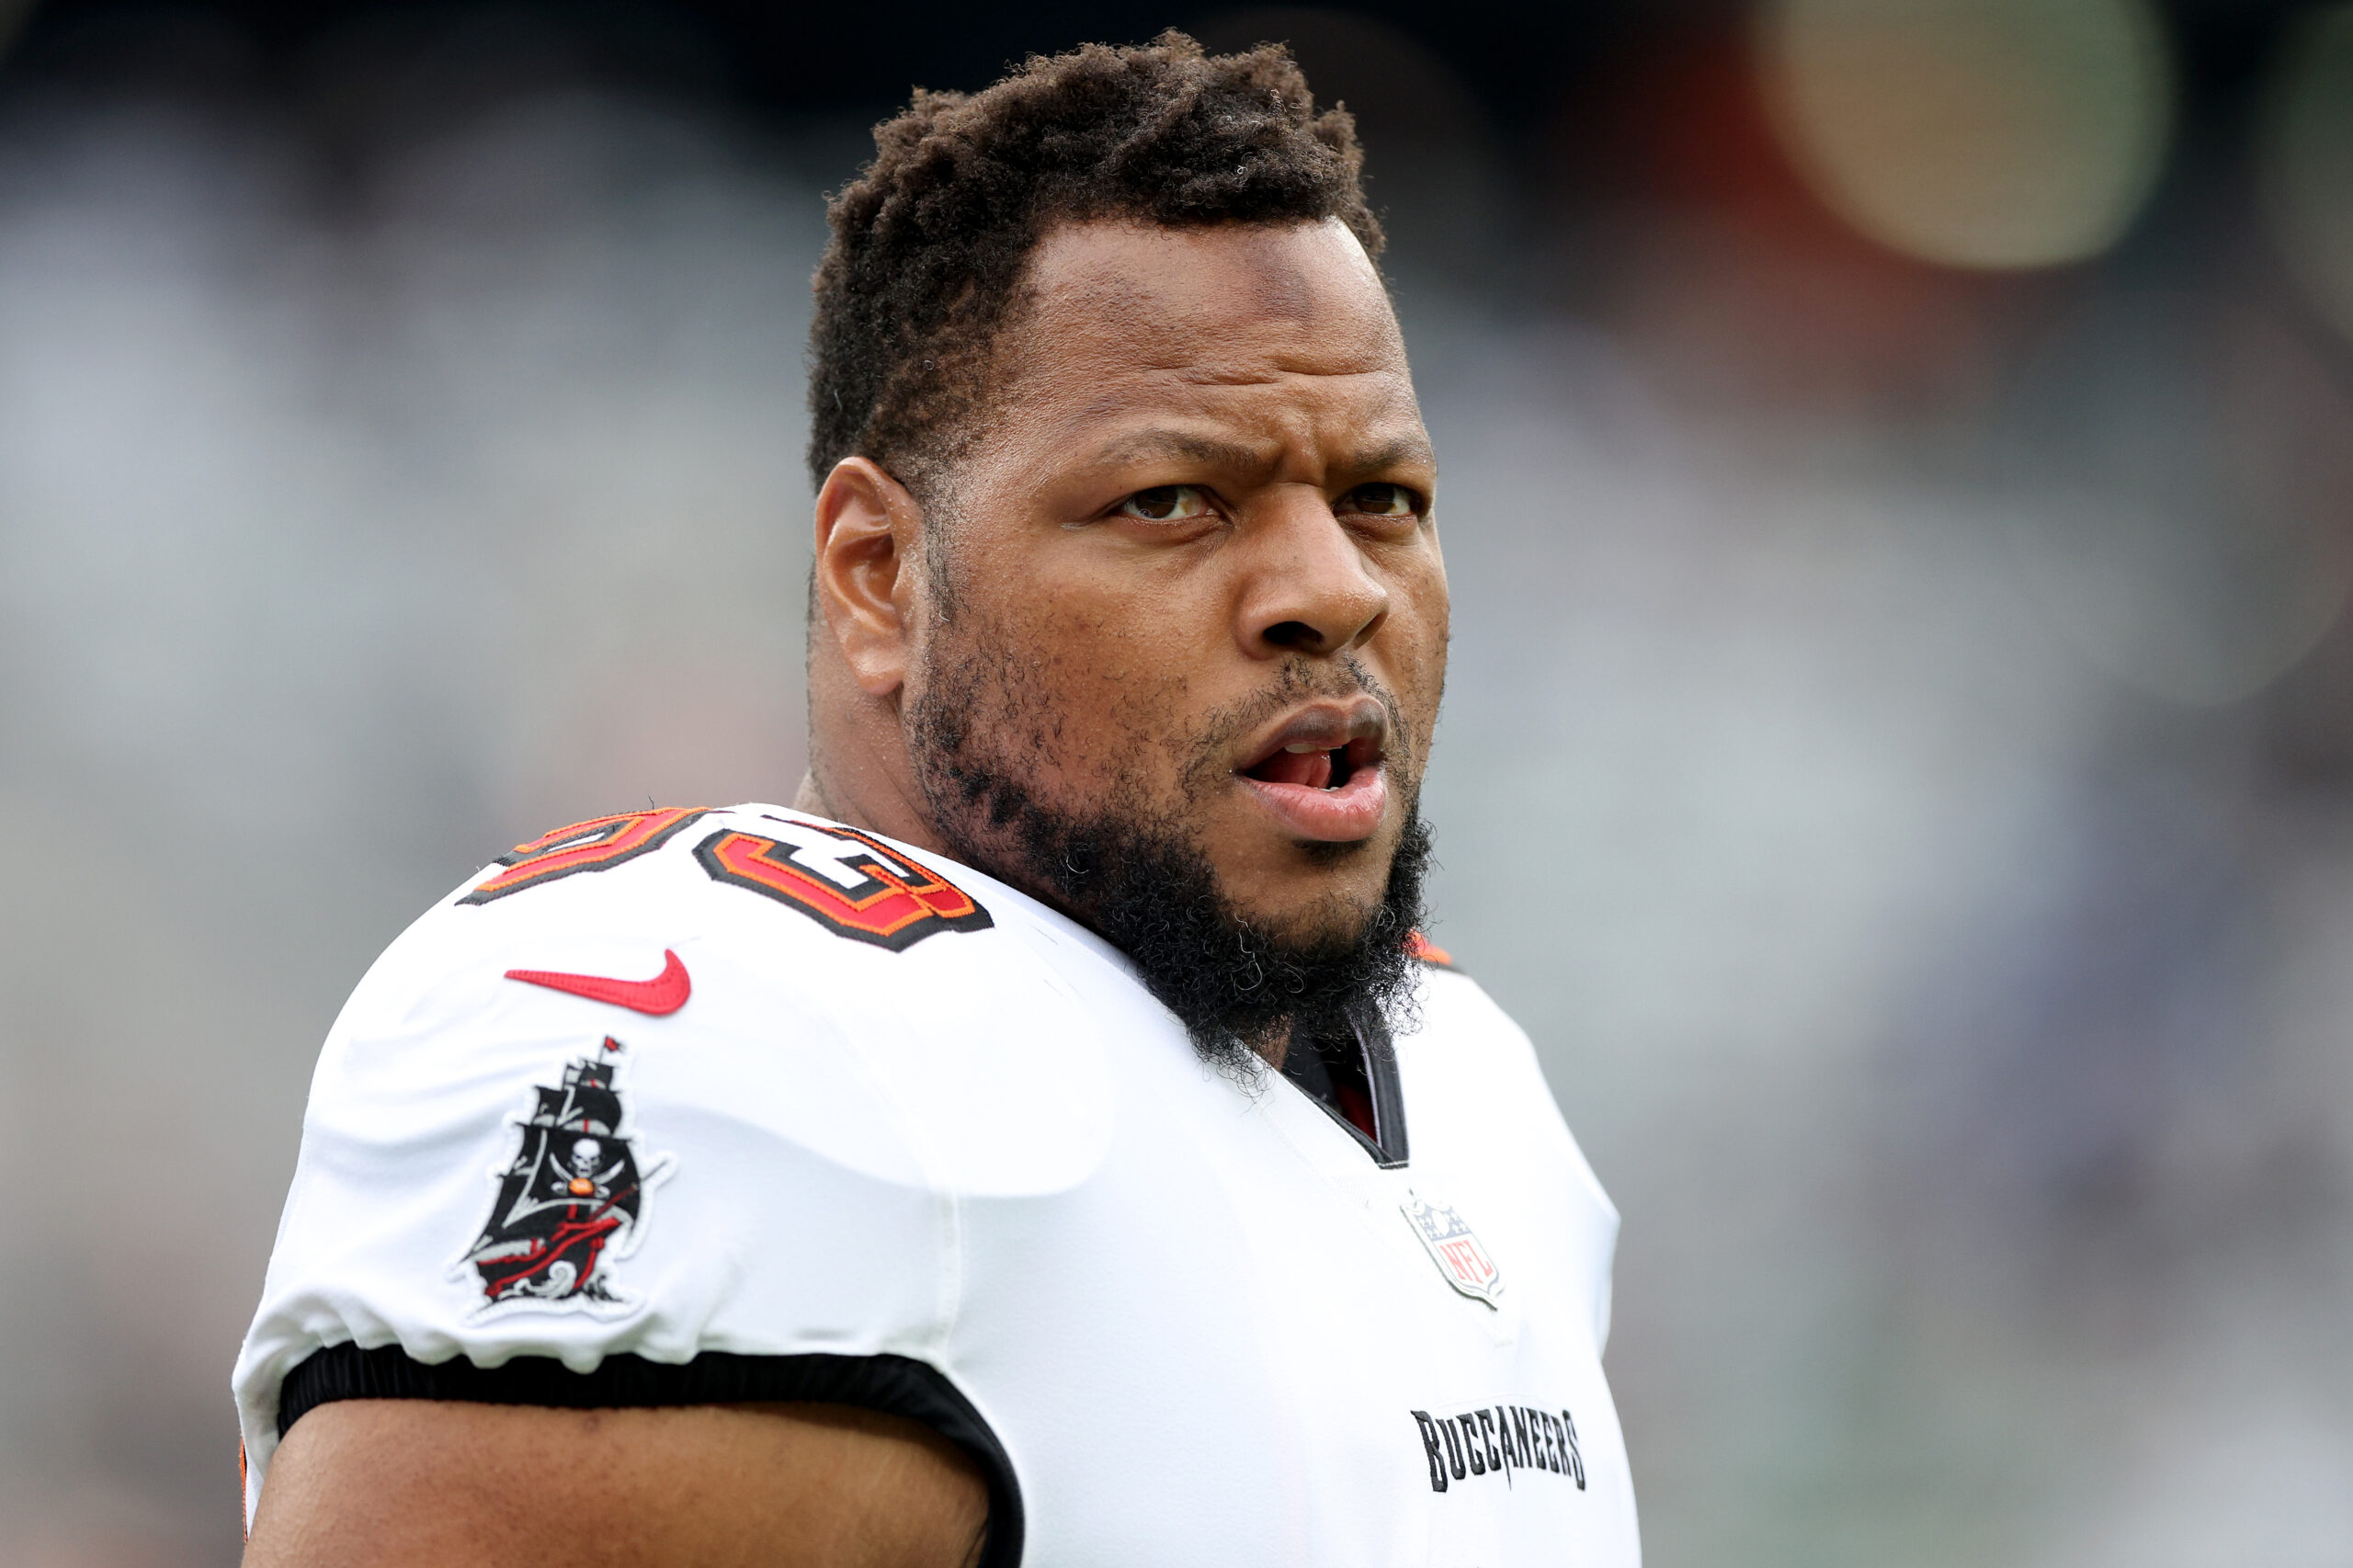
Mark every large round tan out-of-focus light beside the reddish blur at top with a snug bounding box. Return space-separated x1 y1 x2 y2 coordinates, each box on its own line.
1756 0 2172 268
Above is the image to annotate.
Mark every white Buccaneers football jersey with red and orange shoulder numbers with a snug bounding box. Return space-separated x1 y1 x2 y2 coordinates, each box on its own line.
235 805 1638 1568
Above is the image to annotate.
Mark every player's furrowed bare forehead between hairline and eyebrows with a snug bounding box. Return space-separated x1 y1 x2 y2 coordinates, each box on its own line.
1000 219 1419 436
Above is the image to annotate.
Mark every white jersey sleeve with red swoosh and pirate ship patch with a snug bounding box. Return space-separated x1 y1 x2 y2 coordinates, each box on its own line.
233 828 958 1518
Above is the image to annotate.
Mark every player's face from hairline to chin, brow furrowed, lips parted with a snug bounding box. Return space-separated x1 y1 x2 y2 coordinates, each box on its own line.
908 222 1447 944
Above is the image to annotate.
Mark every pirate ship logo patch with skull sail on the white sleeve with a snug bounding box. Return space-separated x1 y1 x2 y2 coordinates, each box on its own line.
459 1036 673 1312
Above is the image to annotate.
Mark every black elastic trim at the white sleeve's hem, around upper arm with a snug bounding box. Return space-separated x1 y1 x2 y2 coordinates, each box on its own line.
278 1345 1024 1568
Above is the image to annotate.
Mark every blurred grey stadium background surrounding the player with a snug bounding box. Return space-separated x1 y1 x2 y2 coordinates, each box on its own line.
0 0 2353 1568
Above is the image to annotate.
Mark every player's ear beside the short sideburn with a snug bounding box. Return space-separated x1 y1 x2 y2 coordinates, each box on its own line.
816 457 923 697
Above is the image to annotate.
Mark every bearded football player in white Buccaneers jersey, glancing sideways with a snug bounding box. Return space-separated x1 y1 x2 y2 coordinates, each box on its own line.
235 33 1638 1568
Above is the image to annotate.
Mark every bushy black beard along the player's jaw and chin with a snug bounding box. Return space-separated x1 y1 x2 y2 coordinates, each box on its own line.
908 644 1430 1074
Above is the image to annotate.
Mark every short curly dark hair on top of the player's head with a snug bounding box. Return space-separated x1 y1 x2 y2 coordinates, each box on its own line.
810 30 1381 494
